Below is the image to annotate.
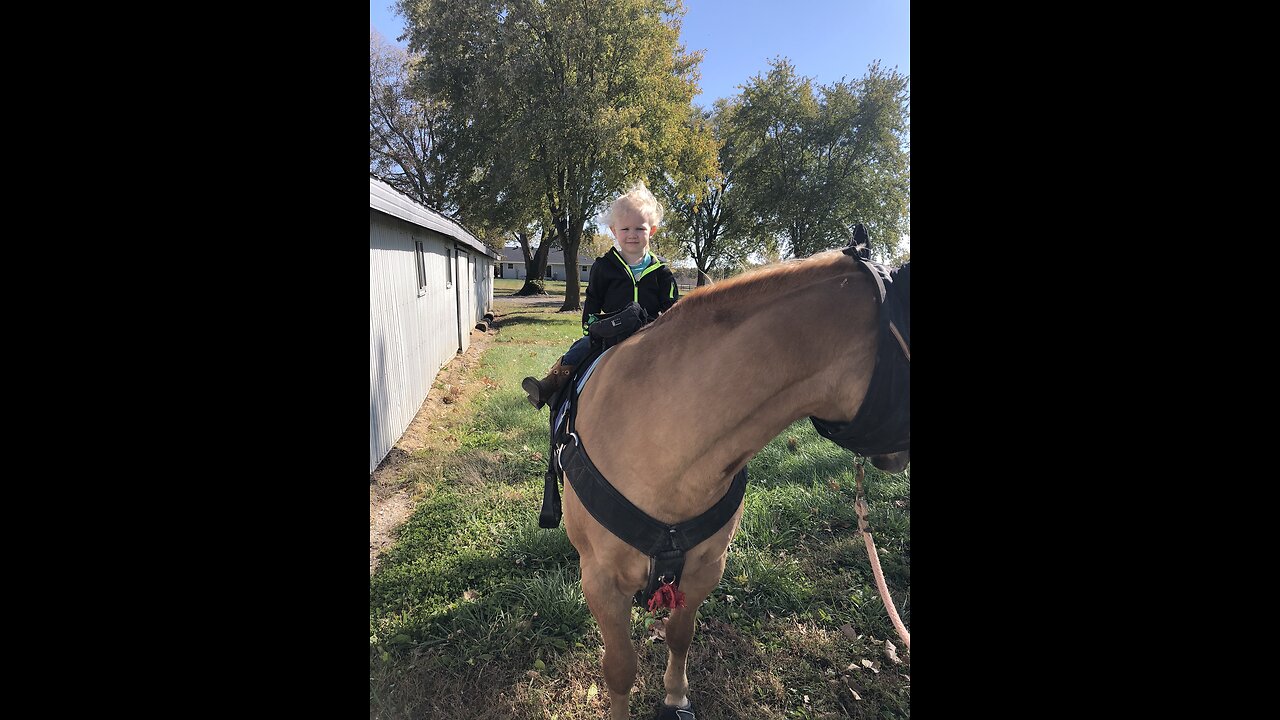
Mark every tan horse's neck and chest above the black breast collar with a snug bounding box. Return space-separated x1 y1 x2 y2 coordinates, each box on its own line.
579 260 876 521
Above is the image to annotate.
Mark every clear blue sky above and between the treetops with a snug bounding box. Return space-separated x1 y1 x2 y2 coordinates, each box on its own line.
369 0 911 108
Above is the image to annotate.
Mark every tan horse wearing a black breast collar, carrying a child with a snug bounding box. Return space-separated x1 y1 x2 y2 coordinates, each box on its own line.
564 244 909 720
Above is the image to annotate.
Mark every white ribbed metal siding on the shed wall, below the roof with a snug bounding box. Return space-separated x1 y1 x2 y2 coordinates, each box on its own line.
369 209 483 473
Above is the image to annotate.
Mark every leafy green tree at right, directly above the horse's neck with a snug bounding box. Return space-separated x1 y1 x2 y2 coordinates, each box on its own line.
730 58 910 258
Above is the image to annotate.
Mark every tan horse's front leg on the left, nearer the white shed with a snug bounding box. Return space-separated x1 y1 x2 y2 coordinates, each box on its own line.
582 564 636 720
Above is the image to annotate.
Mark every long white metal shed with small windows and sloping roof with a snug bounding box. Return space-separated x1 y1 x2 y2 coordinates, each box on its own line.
369 178 498 473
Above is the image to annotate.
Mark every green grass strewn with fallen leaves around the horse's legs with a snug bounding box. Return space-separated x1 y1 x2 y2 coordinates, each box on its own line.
369 294 911 720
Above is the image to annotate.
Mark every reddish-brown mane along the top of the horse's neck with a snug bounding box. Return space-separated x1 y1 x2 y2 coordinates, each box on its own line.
635 250 856 336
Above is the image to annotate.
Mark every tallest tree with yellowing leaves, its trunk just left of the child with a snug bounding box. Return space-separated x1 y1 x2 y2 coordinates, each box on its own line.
399 0 701 311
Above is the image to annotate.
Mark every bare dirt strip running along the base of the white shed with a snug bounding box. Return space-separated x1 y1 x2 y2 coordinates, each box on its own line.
369 289 564 577
